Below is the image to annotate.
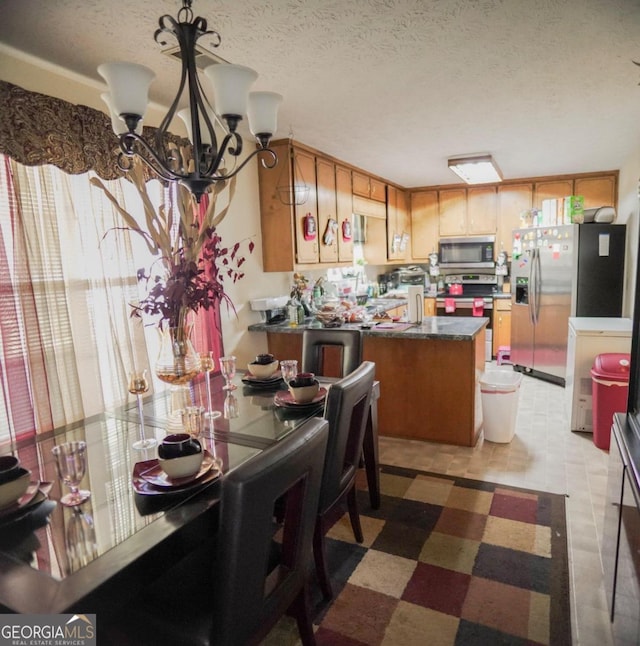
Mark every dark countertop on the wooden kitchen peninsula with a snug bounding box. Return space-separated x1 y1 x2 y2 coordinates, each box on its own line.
248 316 489 341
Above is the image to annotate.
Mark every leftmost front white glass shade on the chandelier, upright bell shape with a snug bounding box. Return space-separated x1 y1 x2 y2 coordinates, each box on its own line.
98 63 156 117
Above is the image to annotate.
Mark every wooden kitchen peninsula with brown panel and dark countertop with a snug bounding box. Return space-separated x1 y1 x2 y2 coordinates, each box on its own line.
249 316 489 446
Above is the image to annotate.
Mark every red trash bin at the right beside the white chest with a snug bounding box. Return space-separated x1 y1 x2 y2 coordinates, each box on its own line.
591 352 631 451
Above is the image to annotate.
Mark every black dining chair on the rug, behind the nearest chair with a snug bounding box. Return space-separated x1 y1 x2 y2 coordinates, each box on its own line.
313 361 376 600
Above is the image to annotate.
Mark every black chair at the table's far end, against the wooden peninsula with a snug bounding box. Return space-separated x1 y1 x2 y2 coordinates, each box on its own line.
301 328 362 377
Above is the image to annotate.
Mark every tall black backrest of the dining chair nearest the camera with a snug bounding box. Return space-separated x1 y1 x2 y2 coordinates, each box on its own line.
212 418 328 646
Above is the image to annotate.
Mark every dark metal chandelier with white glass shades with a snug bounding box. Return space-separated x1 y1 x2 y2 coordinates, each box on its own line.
98 0 282 202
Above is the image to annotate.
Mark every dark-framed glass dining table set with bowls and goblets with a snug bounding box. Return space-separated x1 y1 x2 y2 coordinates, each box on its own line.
0 374 330 615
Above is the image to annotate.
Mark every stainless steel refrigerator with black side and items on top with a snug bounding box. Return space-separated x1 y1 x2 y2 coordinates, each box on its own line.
511 223 626 386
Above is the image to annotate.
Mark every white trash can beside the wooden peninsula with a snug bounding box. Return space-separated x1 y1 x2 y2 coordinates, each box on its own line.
480 370 522 443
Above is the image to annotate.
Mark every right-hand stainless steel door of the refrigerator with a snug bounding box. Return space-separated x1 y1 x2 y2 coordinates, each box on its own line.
533 226 576 380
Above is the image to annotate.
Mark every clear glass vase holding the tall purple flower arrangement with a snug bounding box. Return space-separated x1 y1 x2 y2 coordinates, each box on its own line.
155 325 200 386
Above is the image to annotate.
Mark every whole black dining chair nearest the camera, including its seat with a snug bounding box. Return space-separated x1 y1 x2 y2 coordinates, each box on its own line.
105 418 329 646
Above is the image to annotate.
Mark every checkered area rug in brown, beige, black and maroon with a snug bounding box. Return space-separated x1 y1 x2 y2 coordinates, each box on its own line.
314 465 571 646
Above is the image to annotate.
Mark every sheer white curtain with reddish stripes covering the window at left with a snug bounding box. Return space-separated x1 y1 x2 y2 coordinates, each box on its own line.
0 156 222 440
